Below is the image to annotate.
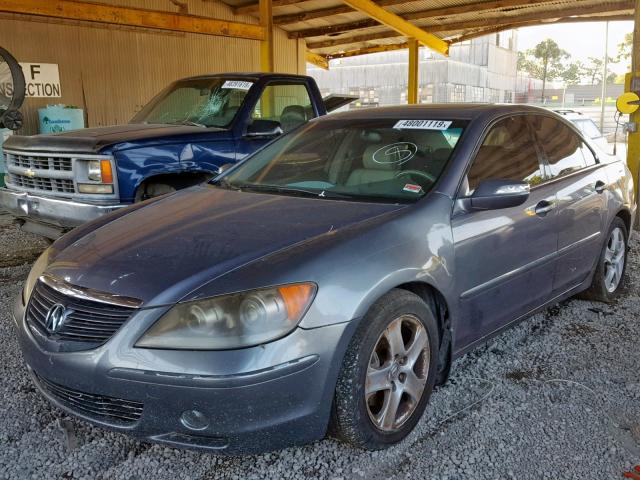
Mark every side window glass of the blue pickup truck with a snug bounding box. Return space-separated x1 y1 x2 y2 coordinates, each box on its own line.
251 84 315 133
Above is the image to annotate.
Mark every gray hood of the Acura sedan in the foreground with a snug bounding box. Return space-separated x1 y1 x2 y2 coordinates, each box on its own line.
47 185 404 306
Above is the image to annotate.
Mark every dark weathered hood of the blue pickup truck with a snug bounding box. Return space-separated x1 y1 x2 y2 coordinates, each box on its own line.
4 123 228 153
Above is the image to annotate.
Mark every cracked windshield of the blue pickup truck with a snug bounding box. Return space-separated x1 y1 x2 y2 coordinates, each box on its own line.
131 78 253 128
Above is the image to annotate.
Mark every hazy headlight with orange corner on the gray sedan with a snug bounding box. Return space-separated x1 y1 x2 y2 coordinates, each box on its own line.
136 283 316 350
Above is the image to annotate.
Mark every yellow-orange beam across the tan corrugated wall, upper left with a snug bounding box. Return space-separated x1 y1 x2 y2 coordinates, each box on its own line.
0 0 264 40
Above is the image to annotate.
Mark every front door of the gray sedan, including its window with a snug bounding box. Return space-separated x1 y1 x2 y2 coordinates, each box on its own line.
452 115 558 349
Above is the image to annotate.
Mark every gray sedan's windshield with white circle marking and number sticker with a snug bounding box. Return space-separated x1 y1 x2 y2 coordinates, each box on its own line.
214 118 466 203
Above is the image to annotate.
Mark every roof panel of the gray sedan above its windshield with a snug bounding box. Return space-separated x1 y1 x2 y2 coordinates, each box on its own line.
327 103 550 120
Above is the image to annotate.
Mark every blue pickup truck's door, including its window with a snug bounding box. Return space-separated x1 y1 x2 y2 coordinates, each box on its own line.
236 80 318 161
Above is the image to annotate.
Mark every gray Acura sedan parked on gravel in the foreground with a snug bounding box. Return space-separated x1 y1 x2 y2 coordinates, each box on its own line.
14 105 636 453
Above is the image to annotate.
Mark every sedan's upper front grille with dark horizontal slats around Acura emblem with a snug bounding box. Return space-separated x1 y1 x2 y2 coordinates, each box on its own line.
26 281 135 346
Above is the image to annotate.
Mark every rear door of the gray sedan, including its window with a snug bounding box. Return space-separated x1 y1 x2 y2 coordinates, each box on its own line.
532 115 608 294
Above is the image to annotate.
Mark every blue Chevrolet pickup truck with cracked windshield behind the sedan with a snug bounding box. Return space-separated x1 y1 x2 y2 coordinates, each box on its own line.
0 73 354 238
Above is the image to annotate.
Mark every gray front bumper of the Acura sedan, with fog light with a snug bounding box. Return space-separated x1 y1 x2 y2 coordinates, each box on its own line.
14 292 353 454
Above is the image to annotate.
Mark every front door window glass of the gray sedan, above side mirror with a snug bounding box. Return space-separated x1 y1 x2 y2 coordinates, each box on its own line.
467 115 544 194
